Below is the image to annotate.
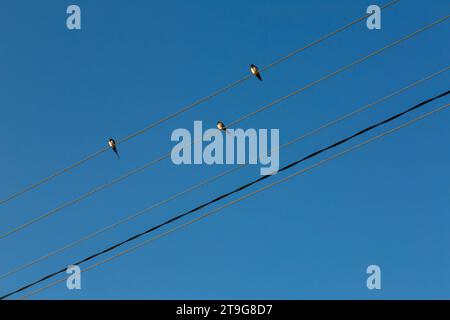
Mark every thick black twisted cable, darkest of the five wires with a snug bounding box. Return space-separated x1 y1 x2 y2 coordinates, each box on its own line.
0 91 450 299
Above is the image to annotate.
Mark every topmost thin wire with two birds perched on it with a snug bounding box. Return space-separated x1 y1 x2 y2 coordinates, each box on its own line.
0 0 400 205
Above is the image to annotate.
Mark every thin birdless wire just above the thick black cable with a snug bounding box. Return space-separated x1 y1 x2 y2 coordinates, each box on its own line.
0 67 450 280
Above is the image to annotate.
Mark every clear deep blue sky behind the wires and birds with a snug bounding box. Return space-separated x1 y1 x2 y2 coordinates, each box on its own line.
0 0 450 299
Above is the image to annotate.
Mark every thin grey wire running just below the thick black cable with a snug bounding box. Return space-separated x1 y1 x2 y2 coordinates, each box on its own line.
20 104 450 300
